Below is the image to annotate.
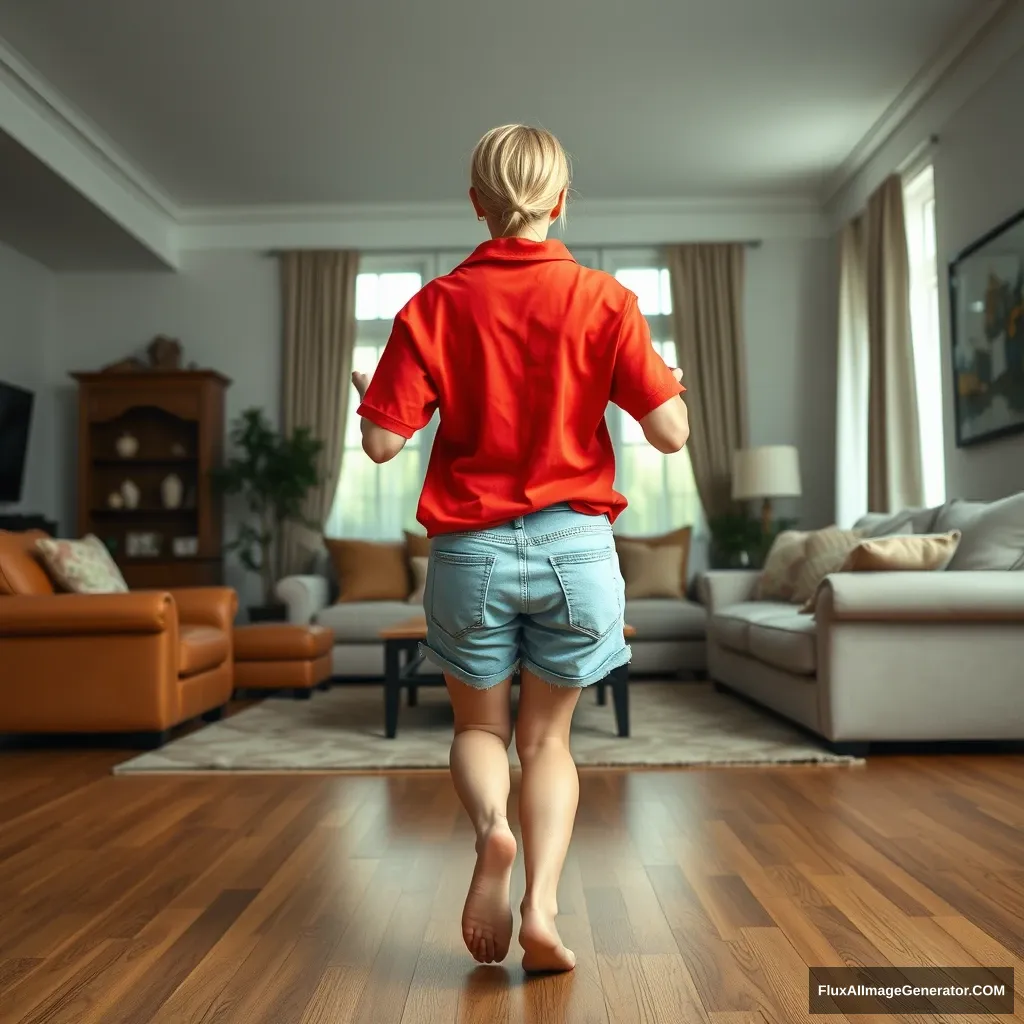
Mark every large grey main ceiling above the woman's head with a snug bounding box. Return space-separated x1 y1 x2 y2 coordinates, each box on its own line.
0 0 977 207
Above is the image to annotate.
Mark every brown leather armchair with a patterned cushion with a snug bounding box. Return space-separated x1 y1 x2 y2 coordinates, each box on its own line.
0 530 238 745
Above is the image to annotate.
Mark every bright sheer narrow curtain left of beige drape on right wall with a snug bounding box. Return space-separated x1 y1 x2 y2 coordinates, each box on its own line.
836 217 868 526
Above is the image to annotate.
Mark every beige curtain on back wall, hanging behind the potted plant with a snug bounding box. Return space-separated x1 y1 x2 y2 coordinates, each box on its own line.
279 251 359 575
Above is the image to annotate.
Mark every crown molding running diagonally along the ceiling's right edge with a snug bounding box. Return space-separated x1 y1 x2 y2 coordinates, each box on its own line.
821 0 1019 207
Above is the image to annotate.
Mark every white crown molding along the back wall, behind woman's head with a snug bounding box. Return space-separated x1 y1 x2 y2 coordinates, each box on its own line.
178 197 827 251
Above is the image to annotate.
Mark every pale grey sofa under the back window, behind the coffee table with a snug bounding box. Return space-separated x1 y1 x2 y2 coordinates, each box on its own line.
276 573 707 679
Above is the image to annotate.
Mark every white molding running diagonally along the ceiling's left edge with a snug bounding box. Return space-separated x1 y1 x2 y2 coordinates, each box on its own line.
0 40 180 267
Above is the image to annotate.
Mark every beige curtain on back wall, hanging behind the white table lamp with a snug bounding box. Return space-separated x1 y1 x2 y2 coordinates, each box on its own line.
666 244 748 518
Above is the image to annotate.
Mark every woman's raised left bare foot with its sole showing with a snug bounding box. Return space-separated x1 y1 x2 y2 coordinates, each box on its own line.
462 818 516 964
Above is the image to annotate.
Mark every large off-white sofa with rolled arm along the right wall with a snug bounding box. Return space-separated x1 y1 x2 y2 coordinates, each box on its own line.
700 494 1024 753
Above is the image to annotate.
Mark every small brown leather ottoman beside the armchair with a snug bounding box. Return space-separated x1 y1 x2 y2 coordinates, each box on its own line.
234 623 334 699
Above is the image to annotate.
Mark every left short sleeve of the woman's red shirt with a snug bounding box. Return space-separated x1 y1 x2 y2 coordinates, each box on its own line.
356 311 437 439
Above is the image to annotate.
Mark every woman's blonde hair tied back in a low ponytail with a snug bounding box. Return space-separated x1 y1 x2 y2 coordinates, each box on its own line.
470 125 570 234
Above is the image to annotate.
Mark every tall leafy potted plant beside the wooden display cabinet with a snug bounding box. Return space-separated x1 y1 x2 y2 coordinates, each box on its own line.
217 409 324 623
